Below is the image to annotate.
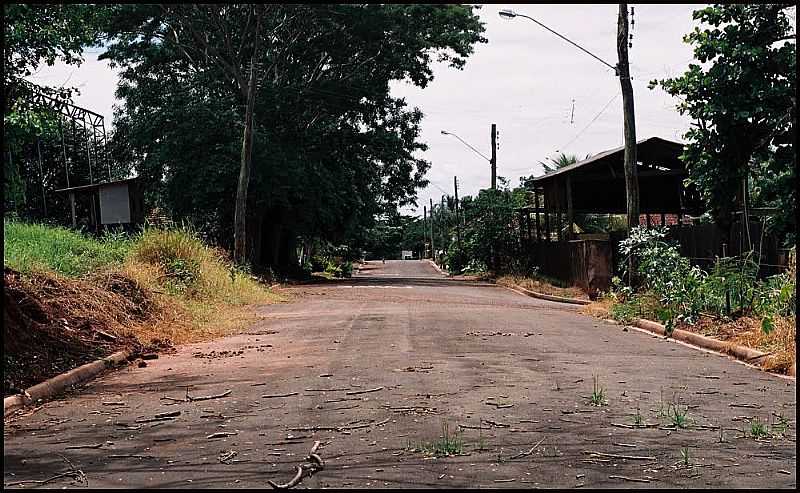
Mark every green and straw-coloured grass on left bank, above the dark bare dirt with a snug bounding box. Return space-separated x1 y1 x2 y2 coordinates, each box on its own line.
3 220 280 346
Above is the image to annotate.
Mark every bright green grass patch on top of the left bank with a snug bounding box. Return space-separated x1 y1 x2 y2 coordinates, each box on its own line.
3 220 132 277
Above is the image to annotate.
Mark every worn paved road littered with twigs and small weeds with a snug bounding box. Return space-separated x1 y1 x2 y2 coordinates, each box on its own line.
3 261 796 488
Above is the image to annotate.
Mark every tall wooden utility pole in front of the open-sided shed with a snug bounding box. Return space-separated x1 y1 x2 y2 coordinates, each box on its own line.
617 3 639 230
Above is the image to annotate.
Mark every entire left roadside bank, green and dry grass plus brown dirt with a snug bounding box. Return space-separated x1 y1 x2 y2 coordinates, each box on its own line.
3 220 282 394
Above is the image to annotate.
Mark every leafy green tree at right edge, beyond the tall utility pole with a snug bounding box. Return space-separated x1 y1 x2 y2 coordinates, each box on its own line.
650 4 797 242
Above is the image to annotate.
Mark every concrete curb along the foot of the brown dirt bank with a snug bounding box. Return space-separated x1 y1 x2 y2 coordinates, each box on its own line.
3 350 131 418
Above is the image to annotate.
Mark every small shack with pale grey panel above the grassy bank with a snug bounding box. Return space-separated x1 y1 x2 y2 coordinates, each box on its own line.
56 178 144 233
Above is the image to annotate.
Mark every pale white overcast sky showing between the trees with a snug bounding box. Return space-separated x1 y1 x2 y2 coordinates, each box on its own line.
26 4 700 215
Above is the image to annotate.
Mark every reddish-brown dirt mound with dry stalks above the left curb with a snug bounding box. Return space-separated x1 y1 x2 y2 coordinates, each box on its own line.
3 268 161 395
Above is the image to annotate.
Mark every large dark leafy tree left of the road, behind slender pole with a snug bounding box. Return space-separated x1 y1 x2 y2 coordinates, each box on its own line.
104 5 485 266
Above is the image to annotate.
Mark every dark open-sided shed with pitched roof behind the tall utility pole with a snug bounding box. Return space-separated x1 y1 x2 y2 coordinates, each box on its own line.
520 137 700 297
